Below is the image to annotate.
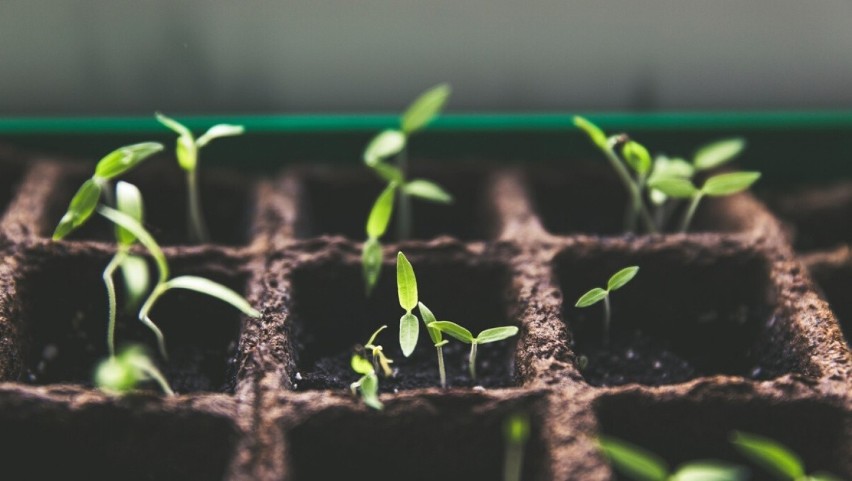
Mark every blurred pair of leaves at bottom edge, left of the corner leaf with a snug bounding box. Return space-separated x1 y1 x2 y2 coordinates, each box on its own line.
598 436 748 481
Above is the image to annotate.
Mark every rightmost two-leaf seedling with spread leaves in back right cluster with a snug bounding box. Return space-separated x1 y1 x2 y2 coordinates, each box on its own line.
650 172 760 232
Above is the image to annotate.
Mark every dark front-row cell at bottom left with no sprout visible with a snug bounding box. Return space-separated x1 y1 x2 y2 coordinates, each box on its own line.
0 403 236 481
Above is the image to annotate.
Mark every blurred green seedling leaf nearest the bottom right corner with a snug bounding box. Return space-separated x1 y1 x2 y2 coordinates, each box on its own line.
731 431 840 481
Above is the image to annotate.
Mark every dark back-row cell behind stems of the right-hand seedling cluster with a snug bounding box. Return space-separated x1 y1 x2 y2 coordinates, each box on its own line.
528 165 751 235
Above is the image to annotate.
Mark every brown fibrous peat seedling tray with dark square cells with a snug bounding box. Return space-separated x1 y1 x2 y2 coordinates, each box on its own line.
0 151 852 481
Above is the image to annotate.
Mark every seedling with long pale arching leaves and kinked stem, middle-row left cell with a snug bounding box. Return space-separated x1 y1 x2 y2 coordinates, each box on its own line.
97 206 260 358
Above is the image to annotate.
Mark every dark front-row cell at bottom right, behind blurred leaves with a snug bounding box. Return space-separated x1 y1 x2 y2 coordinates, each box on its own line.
595 394 852 481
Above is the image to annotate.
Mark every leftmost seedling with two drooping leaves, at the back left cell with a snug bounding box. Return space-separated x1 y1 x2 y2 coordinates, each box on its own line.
53 142 163 240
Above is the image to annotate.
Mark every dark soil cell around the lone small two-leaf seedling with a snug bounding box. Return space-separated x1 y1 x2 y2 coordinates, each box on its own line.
556 248 792 386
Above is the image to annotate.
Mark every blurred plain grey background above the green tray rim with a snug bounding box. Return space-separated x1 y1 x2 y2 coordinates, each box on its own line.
0 0 852 116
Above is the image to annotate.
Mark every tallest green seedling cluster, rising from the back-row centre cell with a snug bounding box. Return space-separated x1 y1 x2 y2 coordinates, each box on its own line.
361 84 453 294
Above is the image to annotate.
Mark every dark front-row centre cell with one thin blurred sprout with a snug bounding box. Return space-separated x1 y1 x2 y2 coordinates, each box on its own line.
286 398 549 481
